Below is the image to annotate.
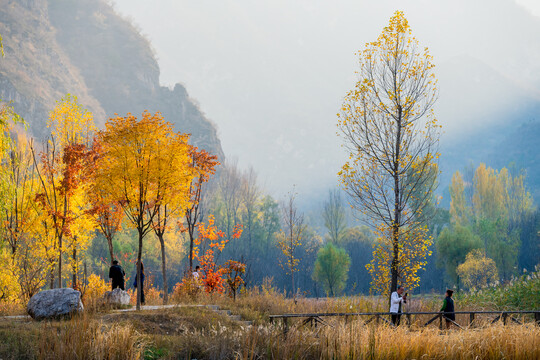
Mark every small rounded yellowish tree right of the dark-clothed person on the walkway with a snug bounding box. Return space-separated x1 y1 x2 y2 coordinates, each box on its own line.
457 249 499 289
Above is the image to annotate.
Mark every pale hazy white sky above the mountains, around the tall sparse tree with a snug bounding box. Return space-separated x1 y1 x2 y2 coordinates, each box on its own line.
114 0 540 195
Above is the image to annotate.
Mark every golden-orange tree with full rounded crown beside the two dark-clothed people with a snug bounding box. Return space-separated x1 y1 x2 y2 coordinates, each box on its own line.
94 111 193 310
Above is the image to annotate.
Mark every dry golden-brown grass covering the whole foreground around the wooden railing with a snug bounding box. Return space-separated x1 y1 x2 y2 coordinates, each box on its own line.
0 289 540 359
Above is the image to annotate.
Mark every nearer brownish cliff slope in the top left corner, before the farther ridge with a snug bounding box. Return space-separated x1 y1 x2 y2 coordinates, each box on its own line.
0 0 105 137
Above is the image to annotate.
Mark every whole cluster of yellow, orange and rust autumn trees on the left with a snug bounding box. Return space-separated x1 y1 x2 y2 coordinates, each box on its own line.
0 94 227 307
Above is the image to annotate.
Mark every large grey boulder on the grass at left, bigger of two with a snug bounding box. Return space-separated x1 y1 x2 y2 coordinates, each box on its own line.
26 288 84 320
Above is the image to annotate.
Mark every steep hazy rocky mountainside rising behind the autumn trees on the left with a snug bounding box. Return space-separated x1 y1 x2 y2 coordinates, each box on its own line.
0 0 223 158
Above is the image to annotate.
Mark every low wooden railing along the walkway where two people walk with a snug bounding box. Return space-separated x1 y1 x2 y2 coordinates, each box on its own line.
270 310 540 337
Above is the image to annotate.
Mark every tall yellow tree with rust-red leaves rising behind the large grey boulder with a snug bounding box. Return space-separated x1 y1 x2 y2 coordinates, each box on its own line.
34 94 95 287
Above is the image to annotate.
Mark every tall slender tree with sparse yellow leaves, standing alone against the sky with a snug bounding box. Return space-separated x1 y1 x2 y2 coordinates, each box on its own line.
338 11 440 293
